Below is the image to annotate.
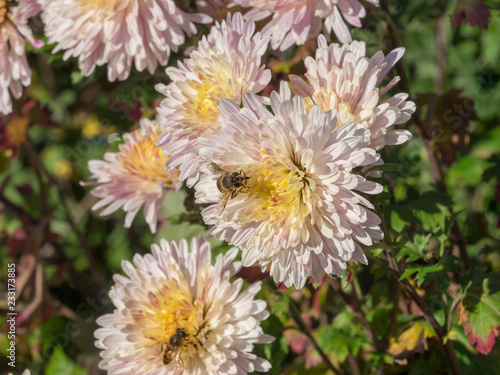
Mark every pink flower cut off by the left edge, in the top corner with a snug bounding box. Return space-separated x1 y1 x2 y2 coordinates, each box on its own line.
0 0 43 114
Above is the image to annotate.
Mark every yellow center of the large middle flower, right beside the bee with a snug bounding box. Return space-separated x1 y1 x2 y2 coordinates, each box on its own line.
239 156 316 228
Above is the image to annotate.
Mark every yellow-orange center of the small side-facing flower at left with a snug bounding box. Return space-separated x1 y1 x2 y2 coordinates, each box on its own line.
117 129 172 185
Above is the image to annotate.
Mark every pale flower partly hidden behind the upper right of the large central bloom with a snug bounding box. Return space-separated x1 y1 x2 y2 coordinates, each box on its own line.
290 35 416 150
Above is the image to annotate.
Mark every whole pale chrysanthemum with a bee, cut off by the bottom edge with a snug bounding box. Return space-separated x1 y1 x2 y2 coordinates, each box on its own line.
95 239 273 375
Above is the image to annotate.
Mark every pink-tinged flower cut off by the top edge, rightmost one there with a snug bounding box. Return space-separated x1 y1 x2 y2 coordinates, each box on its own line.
230 0 378 51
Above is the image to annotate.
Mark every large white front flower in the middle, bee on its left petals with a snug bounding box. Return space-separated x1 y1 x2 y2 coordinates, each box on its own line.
195 83 382 288
